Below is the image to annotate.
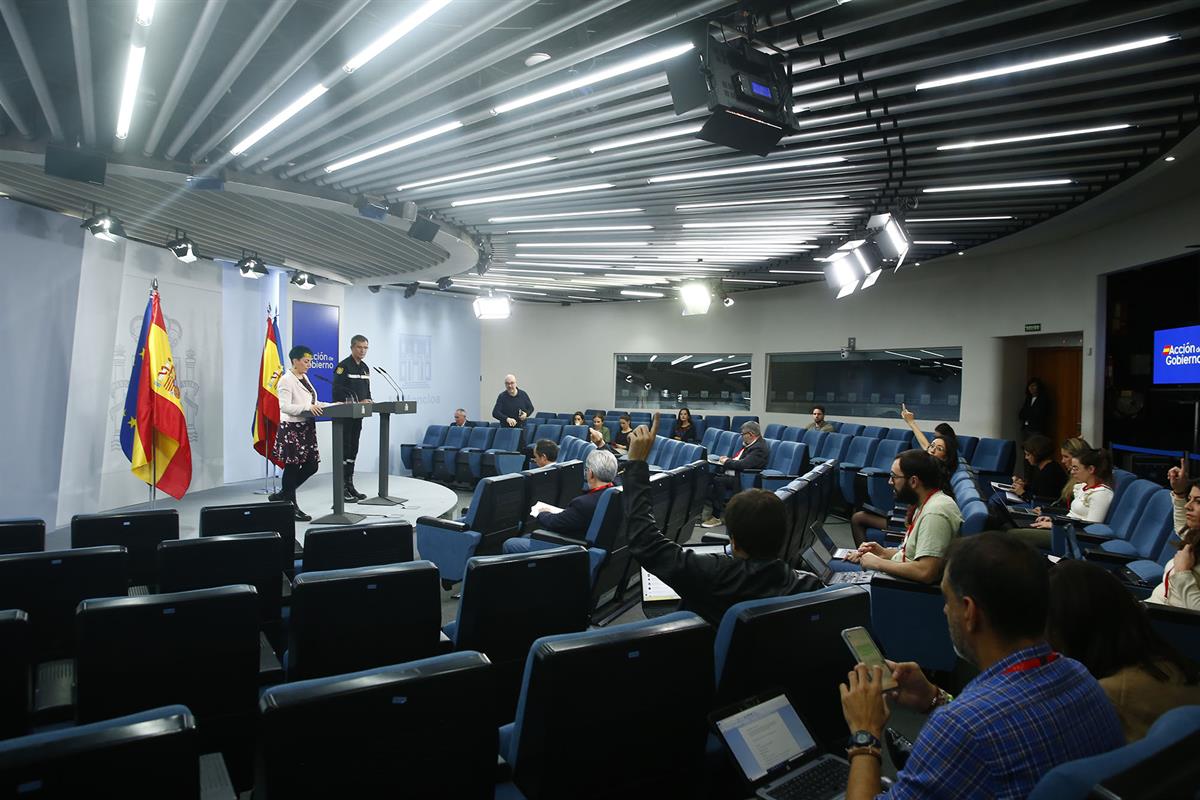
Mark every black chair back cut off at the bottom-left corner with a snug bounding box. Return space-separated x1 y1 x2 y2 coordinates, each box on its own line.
0 705 207 800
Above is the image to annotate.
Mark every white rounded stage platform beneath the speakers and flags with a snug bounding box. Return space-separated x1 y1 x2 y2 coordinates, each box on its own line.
46 473 458 549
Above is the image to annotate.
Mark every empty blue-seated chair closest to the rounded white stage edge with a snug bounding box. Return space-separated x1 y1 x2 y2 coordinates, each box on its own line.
416 473 528 584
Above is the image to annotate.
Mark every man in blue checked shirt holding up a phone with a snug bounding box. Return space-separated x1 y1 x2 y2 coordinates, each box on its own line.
840 533 1124 800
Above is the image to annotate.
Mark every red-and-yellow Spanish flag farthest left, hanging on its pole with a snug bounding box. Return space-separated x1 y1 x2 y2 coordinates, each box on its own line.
121 290 192 500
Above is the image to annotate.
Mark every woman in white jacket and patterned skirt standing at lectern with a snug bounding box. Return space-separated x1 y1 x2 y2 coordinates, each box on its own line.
269 344 325 522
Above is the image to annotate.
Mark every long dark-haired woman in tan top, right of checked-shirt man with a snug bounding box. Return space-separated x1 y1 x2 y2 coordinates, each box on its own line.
1046 561 1200 741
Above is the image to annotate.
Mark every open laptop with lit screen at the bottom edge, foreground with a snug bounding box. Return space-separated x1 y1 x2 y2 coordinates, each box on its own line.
712 692 850 800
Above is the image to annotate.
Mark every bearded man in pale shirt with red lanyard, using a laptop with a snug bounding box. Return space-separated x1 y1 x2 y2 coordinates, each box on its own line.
846 450 962 583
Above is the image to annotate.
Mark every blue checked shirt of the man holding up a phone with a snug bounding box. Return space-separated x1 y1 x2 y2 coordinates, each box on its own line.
880 644 1126 800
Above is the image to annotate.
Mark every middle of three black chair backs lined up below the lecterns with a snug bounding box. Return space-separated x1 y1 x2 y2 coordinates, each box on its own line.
286 561 449 680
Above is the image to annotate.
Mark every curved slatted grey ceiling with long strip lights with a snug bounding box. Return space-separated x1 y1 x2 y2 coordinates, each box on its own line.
0 0 1200 302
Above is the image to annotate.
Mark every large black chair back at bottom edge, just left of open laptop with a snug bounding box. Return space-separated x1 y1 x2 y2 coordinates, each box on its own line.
500 612 713 800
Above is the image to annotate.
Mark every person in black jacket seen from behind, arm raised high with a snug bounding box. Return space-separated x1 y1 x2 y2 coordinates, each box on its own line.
622 415 822 626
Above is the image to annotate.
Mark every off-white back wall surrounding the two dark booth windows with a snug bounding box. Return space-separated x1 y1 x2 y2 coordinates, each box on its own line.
480 167 1200 441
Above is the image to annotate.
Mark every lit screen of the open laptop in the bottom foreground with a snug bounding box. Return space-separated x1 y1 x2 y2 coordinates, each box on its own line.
716 694 817 782
